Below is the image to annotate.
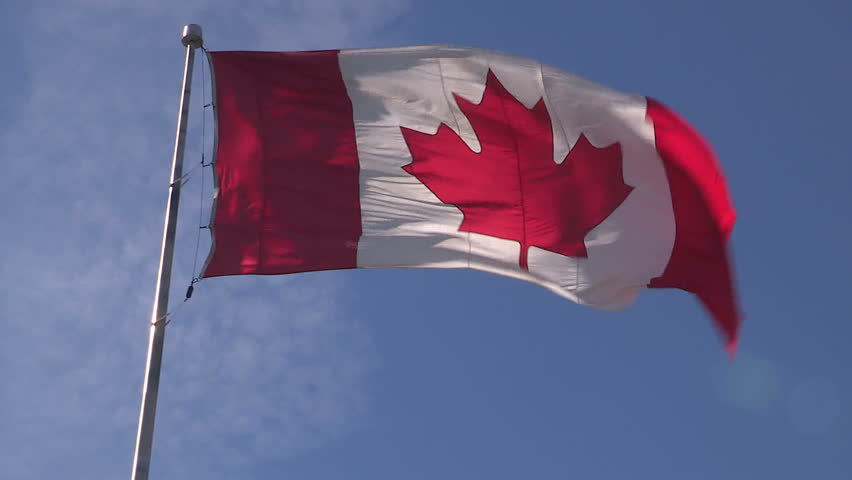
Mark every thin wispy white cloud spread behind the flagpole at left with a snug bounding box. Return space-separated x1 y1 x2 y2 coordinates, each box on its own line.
0 0 404 479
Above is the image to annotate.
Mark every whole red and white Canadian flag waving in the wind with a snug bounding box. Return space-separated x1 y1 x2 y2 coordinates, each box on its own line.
204 46 740 348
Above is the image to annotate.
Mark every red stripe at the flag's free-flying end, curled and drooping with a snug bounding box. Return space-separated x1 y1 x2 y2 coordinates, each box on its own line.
647 98 741 352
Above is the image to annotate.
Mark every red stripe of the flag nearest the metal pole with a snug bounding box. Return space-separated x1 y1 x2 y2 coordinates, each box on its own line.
204 51 361 277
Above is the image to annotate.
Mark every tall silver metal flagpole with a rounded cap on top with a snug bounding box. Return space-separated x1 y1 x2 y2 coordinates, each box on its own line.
131 24 203 480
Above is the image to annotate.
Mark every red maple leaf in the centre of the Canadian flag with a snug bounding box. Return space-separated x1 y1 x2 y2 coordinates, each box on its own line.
401 70 633 270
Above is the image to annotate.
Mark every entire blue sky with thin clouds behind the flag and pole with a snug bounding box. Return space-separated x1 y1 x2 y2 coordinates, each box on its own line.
0 0 852 480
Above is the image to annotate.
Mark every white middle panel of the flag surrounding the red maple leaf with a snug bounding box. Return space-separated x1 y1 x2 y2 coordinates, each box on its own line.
339 46 675 309
